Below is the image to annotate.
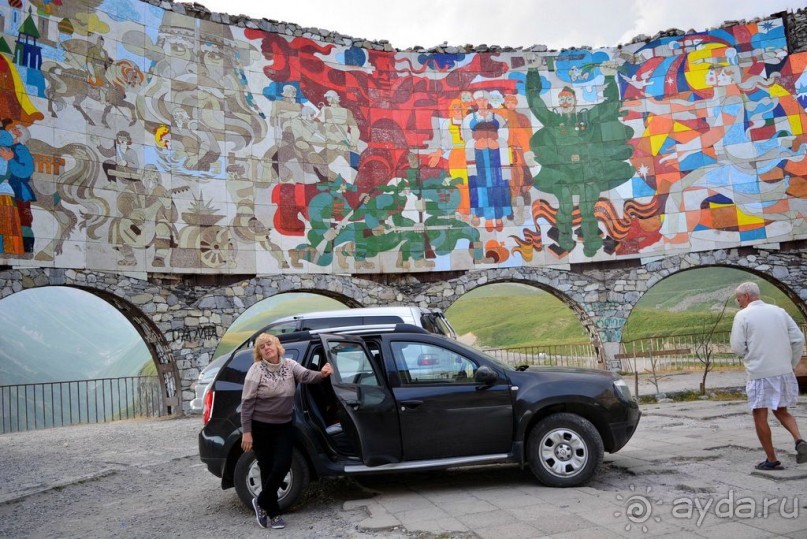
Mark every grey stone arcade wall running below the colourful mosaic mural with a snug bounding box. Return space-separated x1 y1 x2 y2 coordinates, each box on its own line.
0 240 807 410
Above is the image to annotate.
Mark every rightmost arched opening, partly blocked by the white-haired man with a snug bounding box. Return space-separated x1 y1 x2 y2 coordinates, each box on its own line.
618 265 805 375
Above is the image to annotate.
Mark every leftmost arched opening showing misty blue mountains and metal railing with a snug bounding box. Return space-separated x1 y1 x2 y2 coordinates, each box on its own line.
0 286 179 432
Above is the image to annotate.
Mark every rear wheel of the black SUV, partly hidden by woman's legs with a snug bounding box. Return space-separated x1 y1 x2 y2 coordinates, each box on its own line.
235 449 310 511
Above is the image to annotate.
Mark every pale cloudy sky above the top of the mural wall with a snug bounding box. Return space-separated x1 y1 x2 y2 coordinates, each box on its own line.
197 0 807 49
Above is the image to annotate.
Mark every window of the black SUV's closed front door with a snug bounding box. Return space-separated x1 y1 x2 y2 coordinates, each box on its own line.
391 341 478 385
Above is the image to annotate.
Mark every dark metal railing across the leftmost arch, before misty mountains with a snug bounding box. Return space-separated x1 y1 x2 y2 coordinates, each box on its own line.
0 376 164 433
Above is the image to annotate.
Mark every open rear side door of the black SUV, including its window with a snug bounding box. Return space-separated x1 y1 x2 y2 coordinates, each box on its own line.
320 335 402 466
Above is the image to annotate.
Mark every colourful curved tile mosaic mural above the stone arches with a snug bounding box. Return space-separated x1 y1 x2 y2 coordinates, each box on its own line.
0 0 807 273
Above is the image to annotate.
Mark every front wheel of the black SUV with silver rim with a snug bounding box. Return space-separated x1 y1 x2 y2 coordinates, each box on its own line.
527 413 603 487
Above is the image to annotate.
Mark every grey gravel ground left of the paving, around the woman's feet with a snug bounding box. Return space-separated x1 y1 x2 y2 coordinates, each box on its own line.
0 417 413 538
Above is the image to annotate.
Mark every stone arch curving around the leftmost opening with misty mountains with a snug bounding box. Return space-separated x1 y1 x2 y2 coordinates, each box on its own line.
0 268 181 414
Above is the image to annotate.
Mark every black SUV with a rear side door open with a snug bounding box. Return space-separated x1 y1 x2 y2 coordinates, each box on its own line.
199 325 641 510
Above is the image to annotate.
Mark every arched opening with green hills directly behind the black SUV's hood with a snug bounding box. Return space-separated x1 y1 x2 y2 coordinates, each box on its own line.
446 282 600 367
